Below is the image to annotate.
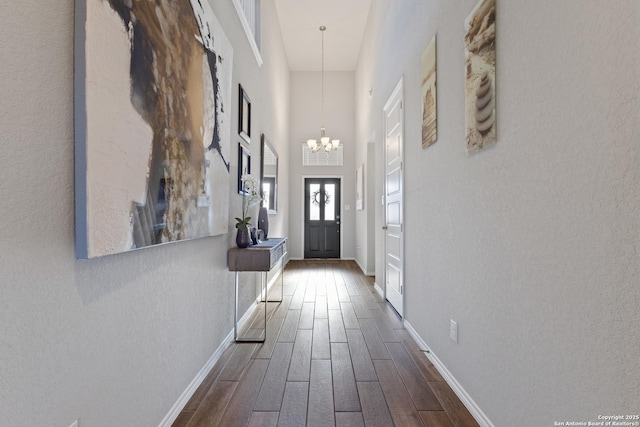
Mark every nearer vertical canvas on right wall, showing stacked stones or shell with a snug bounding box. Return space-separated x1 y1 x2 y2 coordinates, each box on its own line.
464 0 496 153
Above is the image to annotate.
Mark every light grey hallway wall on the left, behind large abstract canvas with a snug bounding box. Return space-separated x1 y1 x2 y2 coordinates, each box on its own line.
0 0 289 427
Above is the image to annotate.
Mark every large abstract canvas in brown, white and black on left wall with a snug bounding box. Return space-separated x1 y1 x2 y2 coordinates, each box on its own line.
75 0 233 258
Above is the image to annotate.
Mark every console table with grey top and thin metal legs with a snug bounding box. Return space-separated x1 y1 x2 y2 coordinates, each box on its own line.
227 237 287 342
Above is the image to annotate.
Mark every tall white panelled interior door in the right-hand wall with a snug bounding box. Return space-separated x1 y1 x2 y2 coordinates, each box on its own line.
383 80 404 317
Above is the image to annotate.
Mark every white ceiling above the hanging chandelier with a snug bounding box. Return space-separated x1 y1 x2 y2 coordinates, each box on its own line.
275 0 371 71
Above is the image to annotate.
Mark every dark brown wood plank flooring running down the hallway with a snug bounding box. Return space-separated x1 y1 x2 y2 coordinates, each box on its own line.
173 261 478 427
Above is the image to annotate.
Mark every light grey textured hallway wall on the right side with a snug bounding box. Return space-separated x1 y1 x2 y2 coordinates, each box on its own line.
355 0 640 427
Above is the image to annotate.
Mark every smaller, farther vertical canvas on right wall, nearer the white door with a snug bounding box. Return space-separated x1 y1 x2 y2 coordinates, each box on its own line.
420 36 438 148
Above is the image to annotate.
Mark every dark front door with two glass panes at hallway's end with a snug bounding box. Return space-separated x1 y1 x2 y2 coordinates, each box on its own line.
304 178 340 258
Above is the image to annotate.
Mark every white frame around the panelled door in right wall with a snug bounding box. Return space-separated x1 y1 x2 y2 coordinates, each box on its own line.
382 76 406 319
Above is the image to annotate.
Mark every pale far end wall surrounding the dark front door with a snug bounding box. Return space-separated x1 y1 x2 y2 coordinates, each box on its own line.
289 71 358 259
